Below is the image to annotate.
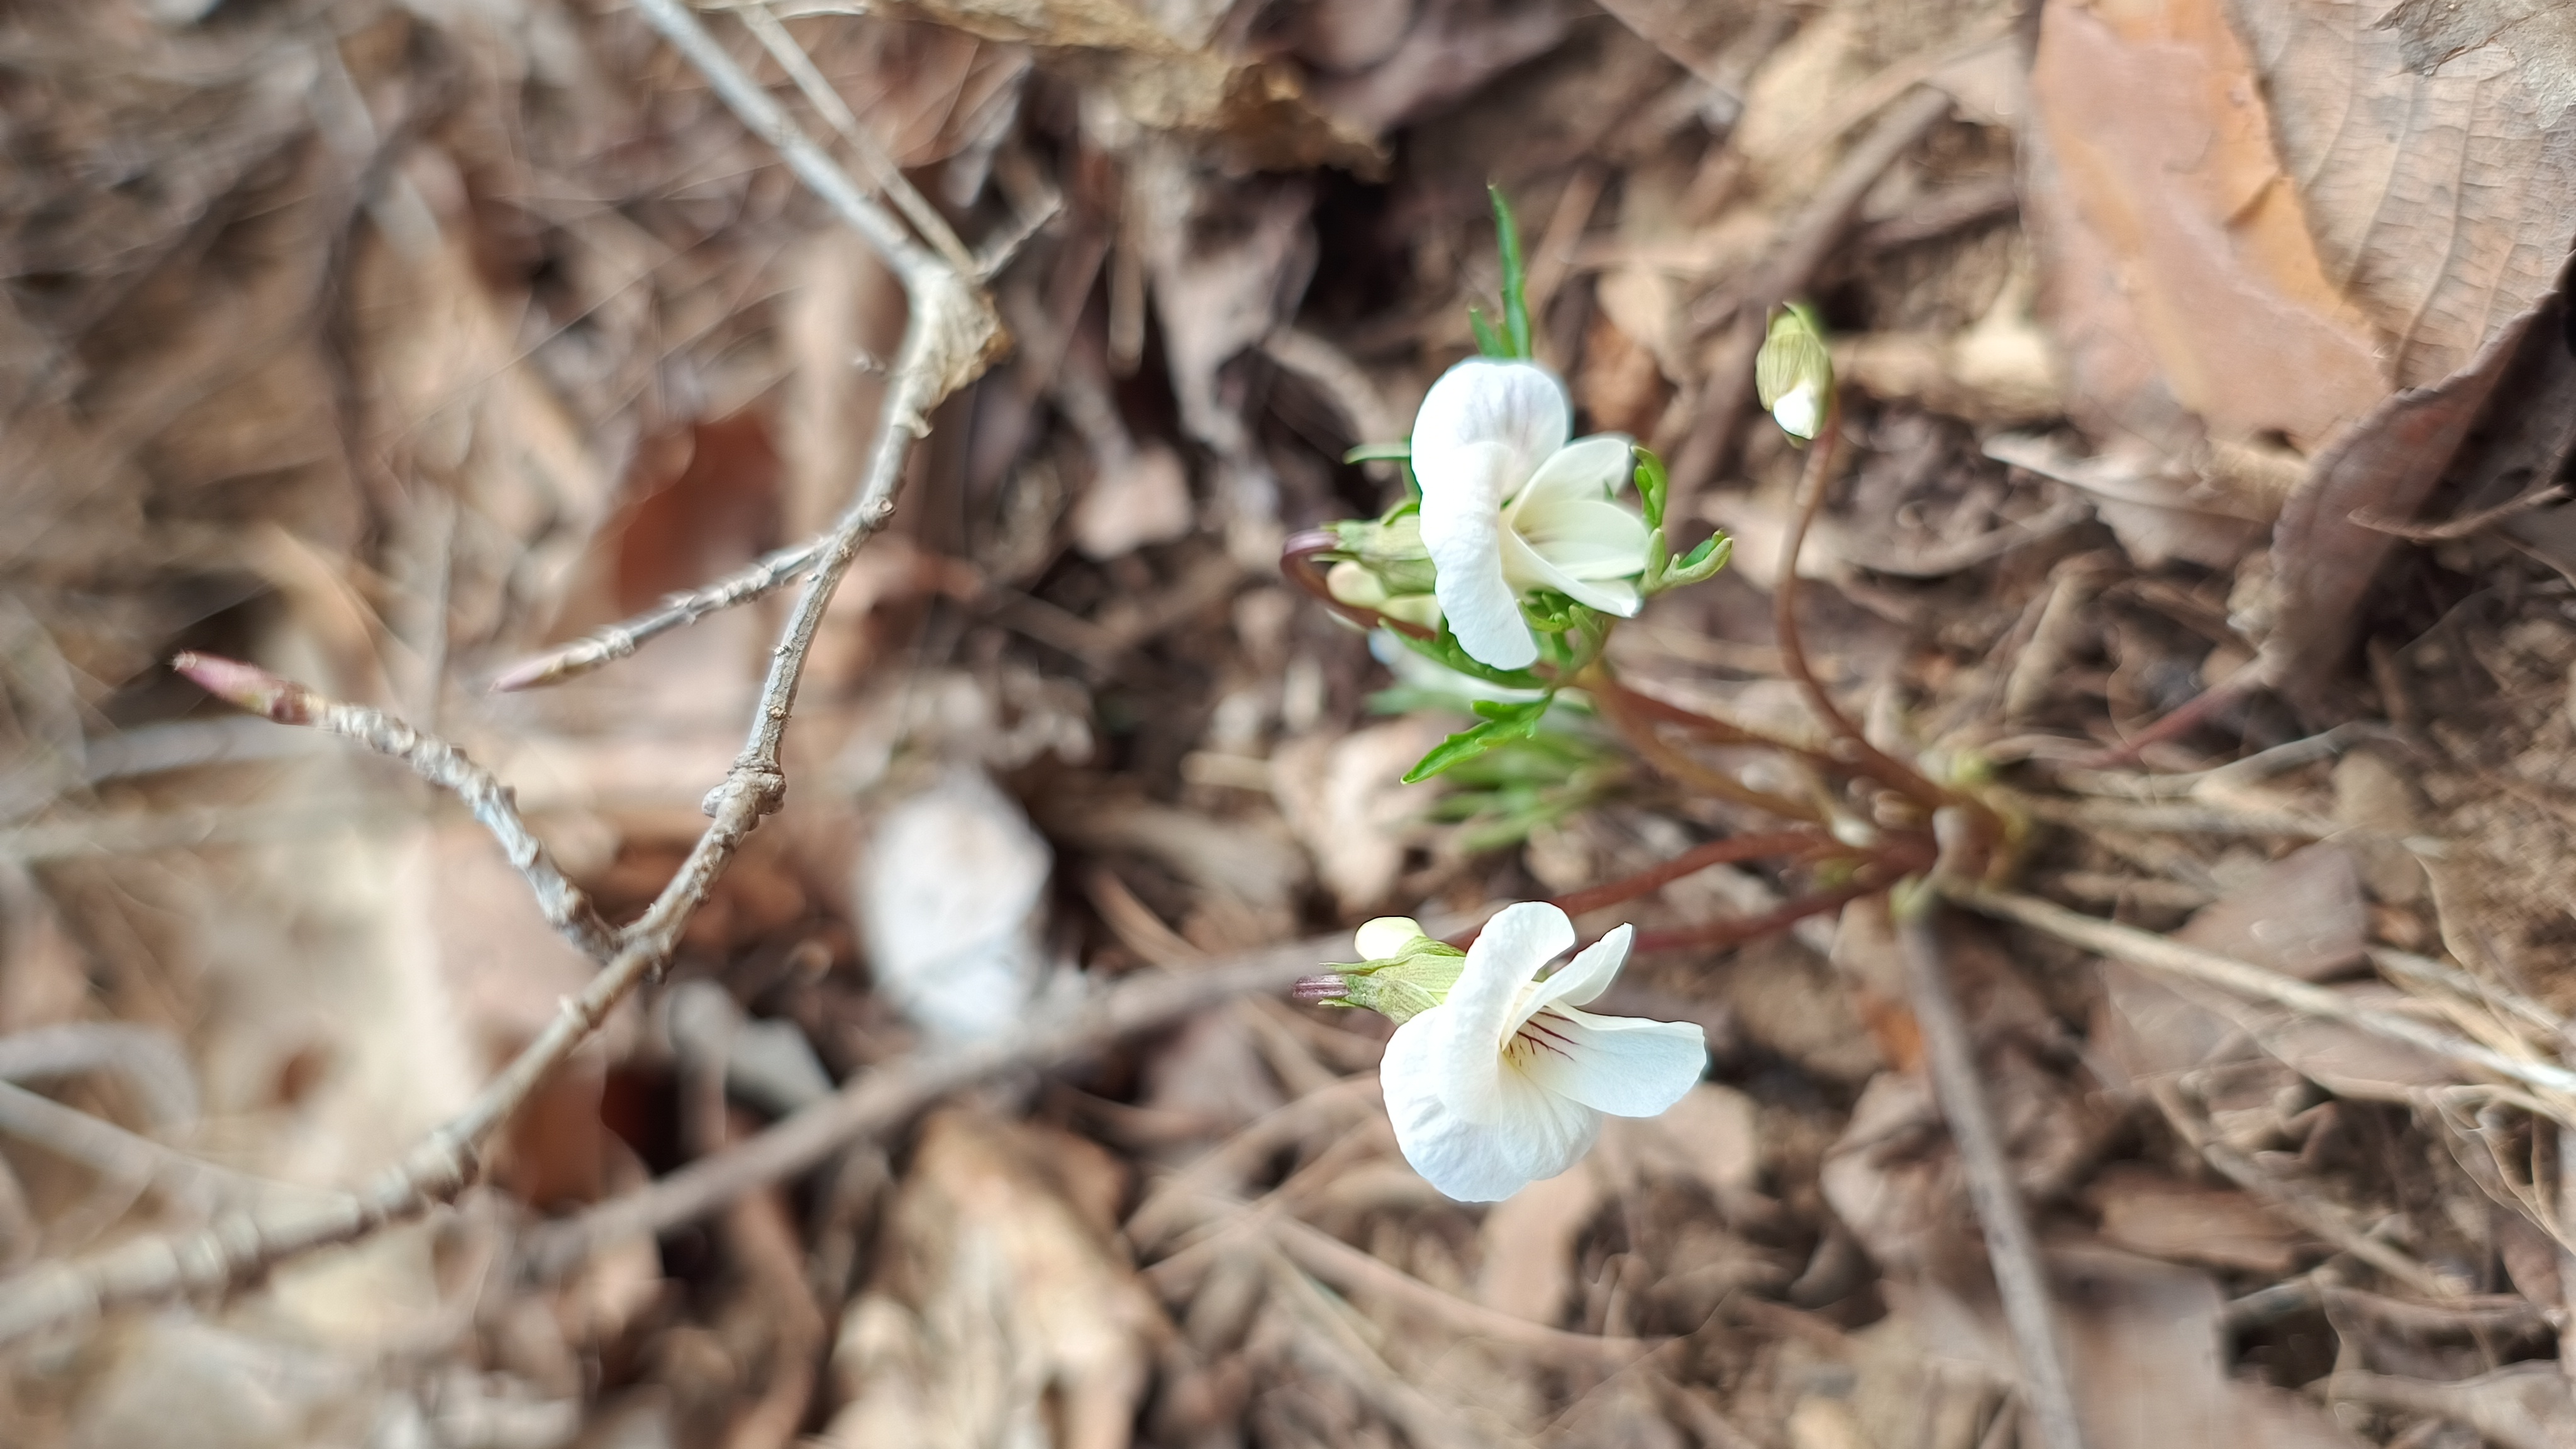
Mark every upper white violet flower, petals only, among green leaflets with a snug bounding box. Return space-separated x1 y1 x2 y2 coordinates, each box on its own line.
1412 358 1646 670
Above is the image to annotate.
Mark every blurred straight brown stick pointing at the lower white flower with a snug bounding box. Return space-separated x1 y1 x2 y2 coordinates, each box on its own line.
510 936 1350 1279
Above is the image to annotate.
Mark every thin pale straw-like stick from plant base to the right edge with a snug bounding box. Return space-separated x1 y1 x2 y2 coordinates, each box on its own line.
1945 884 2576 1103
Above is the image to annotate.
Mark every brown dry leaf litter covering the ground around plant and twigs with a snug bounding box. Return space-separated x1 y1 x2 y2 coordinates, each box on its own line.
0 0 2576 1449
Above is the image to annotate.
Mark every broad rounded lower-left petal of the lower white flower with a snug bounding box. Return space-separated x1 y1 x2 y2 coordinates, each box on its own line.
1378 998 1602 1201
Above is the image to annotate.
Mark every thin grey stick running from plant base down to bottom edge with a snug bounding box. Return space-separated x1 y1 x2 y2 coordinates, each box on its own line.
1896 910 2084 1449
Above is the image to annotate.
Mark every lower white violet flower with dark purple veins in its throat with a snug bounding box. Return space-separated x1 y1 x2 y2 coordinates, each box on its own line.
1360 902 1708 1201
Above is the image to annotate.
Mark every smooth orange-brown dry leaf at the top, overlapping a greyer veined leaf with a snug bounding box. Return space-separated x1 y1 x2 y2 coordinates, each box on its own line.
2024 0 2388 451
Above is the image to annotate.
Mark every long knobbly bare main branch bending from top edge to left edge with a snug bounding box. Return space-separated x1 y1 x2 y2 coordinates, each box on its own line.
0 0 999 1346
